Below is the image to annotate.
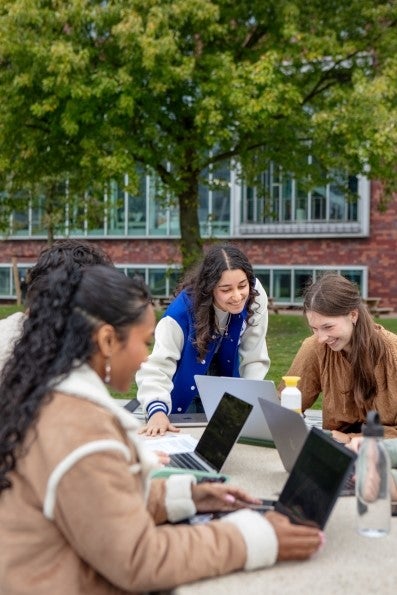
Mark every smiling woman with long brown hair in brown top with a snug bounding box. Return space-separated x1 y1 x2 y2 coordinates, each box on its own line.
280 273 397 442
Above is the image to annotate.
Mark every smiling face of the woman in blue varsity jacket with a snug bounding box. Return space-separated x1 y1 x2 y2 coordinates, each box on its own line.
213 269 250 314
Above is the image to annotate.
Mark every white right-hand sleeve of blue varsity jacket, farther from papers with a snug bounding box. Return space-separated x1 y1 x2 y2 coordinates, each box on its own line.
239 279 270 380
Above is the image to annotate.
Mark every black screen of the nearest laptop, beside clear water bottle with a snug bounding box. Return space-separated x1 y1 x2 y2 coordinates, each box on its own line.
276 428 356 529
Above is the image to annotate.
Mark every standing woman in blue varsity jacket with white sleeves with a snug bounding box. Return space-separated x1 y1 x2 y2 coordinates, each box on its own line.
136 244 270 436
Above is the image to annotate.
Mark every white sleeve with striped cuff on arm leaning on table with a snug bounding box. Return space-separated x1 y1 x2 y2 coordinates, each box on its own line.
135 316 184 416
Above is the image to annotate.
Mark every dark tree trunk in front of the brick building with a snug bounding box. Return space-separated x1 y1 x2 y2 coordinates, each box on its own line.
178 172 203 271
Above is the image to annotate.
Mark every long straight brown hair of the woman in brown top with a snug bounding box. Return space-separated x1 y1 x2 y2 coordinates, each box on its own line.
303 273 385 413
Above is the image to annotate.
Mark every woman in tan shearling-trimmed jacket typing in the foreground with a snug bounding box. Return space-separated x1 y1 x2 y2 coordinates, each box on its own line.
0 266 322 595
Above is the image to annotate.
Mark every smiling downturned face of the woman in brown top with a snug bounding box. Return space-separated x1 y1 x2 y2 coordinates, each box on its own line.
306 310 358 353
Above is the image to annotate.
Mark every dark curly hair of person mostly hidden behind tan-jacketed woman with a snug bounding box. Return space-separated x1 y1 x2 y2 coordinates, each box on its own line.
26 238 113 305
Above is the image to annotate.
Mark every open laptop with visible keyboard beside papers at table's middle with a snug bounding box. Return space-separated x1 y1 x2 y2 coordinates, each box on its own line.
168 392 252 473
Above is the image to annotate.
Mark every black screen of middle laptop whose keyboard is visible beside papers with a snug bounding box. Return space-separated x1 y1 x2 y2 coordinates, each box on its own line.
195 393 252 470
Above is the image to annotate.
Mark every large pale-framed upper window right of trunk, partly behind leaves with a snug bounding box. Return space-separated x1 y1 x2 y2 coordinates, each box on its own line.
239 164 369 236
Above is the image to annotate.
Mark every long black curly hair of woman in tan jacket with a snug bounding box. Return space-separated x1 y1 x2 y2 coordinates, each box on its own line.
0 265 151 491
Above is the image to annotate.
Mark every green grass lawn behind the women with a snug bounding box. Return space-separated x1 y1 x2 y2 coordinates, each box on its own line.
0 305 397 408
